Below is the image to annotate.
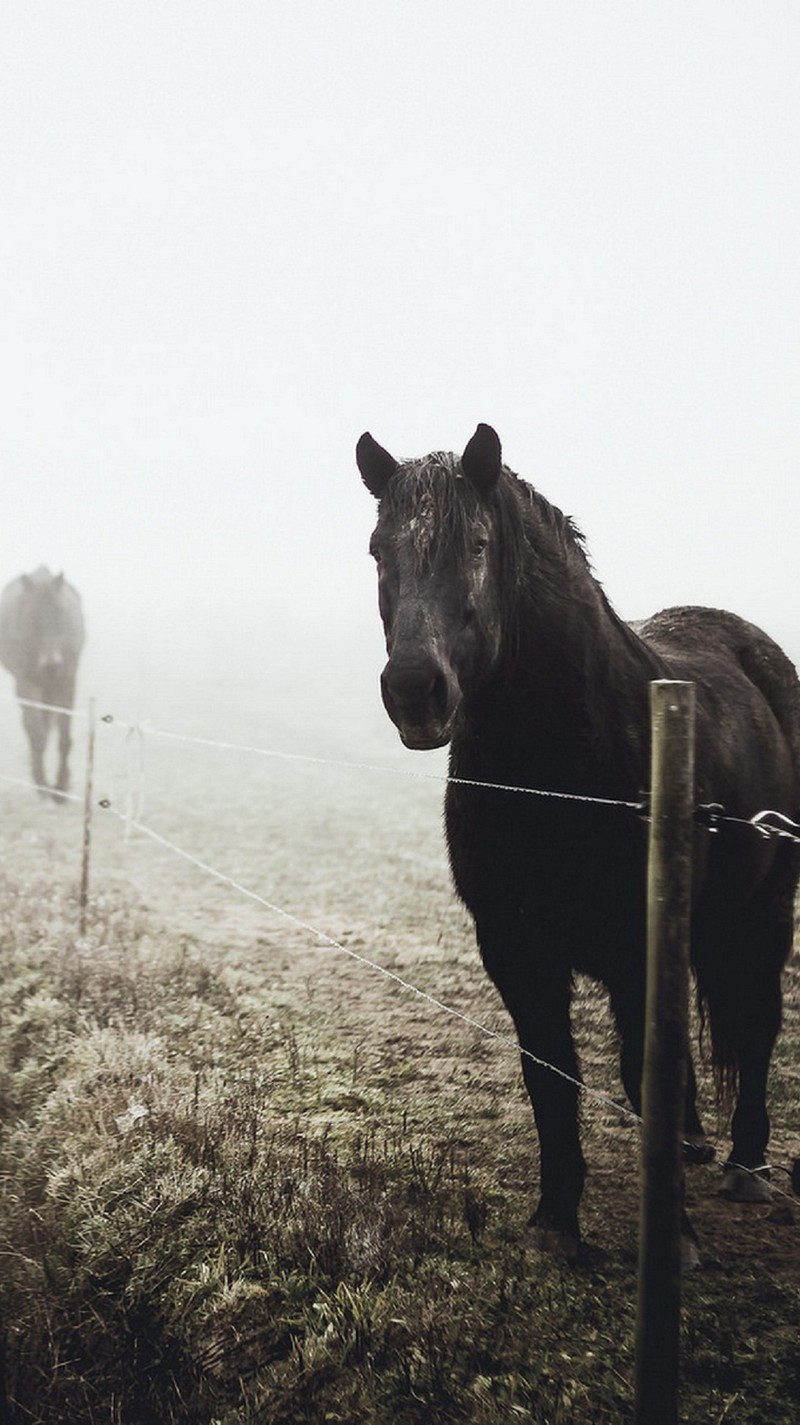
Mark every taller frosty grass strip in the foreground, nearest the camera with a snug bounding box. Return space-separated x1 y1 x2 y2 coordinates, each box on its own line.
0 881 800 1425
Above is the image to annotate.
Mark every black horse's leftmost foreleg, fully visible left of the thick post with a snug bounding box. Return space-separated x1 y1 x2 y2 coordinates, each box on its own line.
479 928 586 1260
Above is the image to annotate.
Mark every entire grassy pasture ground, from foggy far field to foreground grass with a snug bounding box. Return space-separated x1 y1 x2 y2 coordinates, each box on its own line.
0 660 800 1425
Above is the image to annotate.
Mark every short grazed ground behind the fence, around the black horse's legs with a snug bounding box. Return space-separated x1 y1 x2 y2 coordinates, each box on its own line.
0 684 800 1283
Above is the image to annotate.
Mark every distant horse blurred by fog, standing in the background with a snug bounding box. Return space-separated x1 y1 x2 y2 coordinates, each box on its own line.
0 567 84 801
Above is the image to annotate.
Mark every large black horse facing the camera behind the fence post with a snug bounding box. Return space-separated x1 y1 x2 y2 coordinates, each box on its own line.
357 425 800 1257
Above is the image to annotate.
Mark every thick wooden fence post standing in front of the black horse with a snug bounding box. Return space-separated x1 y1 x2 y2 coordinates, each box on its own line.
633 681 694 1425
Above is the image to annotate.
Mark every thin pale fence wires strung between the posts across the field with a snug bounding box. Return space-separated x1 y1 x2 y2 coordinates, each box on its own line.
0 686 800 1197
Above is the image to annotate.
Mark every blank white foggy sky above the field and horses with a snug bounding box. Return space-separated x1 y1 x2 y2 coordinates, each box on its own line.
0 0 800 706
